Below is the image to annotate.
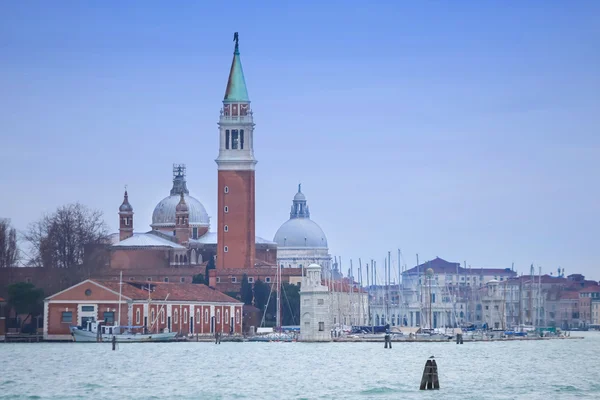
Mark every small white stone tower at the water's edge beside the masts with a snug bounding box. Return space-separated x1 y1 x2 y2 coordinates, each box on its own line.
300 264 331 342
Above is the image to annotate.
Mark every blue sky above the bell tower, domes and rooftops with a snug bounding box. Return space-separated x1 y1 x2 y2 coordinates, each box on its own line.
0 1 600 279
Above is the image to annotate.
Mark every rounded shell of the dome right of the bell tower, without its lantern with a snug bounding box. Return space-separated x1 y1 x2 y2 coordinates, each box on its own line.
273 218 327 248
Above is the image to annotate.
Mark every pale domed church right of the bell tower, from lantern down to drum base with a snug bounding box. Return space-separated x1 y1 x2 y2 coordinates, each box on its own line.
273 185 332 277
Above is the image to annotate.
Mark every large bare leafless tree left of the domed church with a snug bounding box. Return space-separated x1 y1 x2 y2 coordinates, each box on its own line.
24 203 108 268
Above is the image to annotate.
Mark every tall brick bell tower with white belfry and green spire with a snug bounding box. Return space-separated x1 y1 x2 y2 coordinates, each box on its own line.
215 32 256 270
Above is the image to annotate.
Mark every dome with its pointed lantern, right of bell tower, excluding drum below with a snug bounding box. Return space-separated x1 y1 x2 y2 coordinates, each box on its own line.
273 185 327 248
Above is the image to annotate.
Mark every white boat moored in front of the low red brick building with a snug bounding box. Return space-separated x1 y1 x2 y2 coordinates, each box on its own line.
70 321 177 343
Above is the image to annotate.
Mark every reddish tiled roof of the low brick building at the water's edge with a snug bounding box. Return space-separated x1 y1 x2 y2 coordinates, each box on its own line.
94 280 239 303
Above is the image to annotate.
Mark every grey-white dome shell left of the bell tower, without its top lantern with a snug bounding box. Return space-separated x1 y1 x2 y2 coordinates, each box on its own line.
150 194 210 229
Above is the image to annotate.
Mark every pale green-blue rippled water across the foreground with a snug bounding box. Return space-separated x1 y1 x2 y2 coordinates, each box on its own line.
0 333 600 400
